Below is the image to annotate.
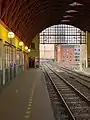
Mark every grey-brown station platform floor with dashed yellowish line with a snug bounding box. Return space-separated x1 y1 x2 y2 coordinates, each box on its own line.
0 68 55 120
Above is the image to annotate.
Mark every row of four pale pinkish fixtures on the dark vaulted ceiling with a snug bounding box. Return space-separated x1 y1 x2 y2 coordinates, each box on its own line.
61 2 83 22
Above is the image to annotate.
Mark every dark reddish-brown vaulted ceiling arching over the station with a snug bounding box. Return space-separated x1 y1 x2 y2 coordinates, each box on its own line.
0 0 90 45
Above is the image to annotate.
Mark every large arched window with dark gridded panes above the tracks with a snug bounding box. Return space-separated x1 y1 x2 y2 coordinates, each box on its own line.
40 24 86 44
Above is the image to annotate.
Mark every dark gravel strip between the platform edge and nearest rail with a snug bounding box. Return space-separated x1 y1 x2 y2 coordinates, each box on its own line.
43 67 75 120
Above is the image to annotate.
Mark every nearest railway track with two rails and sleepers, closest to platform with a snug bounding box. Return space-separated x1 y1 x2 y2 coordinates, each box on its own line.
44 65 90 120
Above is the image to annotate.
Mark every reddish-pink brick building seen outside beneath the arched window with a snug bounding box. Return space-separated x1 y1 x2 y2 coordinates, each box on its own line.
56 45 80 64
